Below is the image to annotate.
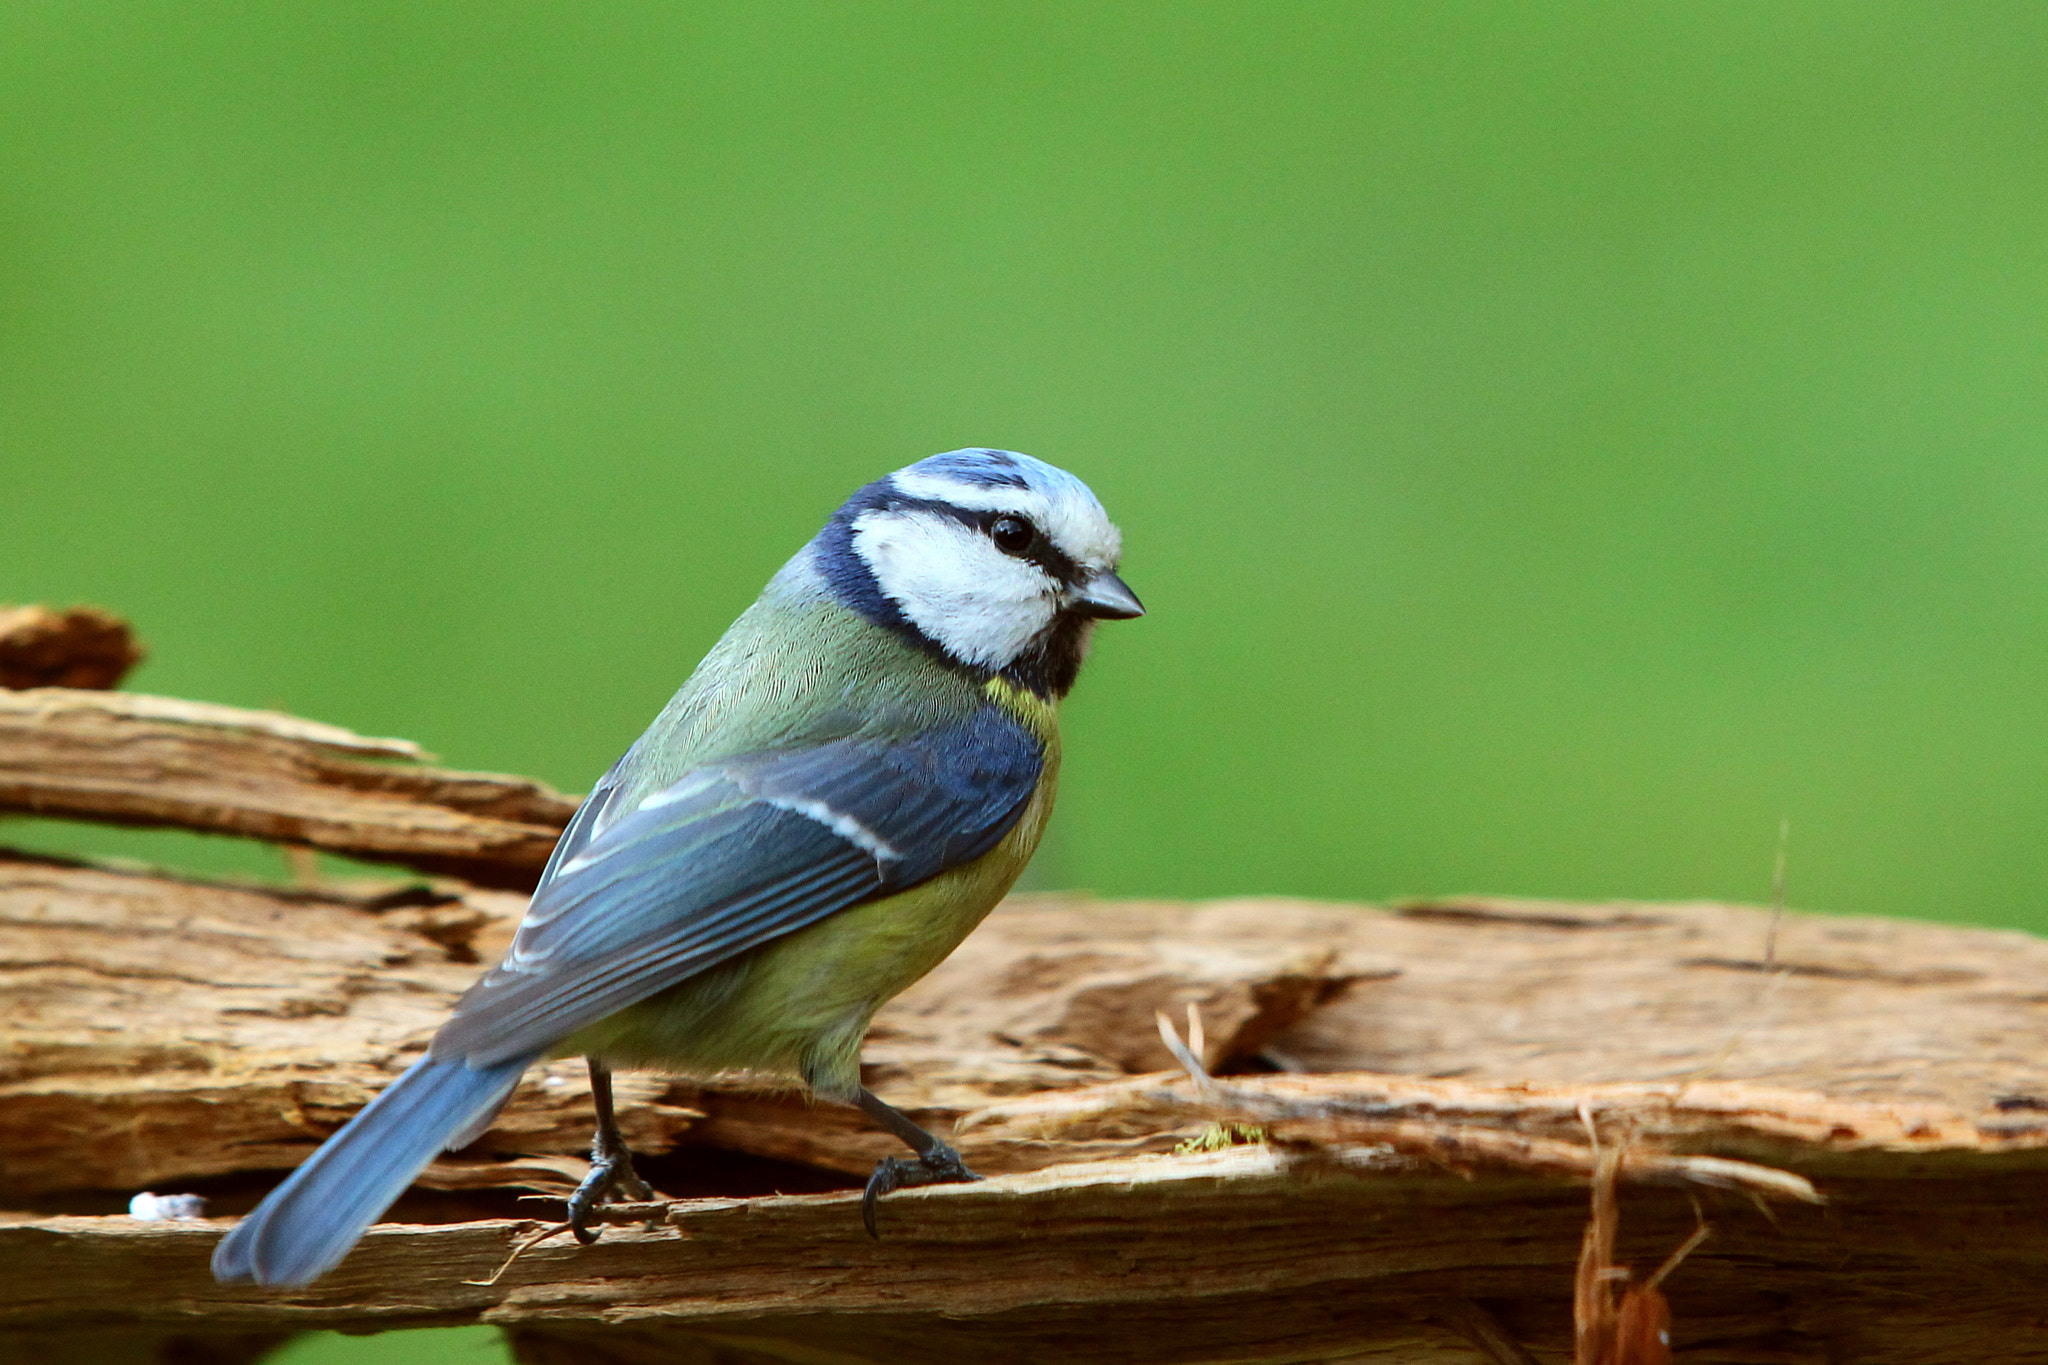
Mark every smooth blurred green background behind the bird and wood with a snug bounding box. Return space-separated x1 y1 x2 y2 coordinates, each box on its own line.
0 0 2048 1359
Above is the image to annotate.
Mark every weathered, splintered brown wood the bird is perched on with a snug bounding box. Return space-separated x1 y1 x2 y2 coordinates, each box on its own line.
0 690 2048 1365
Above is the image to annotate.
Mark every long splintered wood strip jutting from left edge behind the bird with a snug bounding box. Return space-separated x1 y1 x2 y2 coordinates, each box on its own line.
0 688 578 890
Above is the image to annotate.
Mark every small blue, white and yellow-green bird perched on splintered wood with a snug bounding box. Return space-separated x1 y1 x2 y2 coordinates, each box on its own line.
213 448 1145 1287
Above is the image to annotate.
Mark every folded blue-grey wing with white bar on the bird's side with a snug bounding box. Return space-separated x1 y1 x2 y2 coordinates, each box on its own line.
432 706 1044 1066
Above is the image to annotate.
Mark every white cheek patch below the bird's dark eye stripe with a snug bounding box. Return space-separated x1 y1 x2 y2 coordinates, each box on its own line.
854 507 1059 669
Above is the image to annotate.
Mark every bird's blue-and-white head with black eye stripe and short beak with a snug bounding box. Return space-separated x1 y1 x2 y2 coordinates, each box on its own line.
817 450 1145 696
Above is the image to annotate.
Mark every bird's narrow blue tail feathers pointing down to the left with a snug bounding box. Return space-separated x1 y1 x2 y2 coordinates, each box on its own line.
213 1056 535 1285
